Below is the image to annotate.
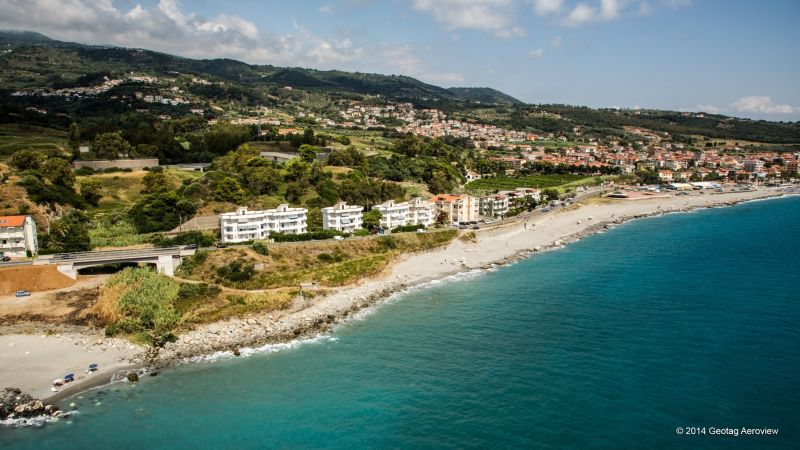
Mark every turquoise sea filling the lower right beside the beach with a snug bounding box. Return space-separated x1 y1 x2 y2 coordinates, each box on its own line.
0 198 800 450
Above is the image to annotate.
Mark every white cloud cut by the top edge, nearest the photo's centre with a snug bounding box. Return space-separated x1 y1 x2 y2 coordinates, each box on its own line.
412 0 525 38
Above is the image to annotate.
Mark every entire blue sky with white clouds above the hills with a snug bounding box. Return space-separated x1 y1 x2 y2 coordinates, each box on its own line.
0 0 800 121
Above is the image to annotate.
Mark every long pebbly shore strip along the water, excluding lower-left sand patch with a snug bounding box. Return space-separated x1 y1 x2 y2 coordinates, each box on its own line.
0 188 785 404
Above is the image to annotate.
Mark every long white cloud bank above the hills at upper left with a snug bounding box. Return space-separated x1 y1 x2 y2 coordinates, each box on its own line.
0 0 365 68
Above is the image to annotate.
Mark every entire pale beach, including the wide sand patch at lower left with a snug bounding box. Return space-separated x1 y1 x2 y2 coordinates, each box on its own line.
0 184 792 401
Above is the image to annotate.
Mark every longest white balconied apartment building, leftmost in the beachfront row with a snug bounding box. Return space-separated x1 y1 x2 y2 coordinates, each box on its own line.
219 205 308 242
